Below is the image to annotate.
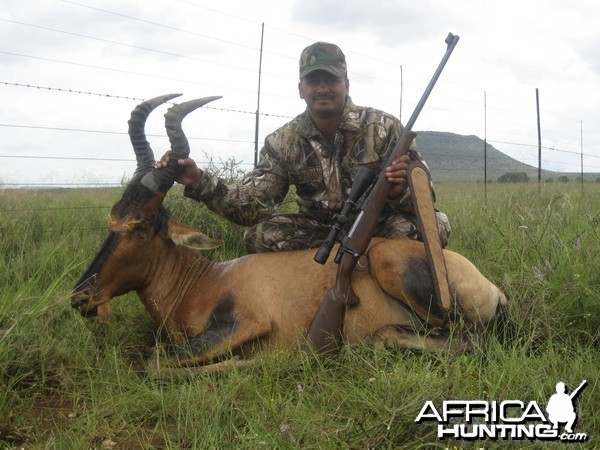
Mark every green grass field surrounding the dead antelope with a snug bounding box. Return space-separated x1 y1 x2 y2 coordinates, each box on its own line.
0 183 600 449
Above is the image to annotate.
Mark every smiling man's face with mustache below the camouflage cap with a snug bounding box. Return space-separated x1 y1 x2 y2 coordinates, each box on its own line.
298 70 349 118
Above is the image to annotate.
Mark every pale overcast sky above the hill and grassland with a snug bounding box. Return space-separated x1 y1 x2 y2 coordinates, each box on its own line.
0 0 600 187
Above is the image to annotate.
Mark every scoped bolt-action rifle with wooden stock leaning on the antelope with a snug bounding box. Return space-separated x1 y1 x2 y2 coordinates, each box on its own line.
308 33 459 353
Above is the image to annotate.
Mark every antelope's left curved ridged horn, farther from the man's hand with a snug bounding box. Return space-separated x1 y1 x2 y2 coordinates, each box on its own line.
127 94 181 179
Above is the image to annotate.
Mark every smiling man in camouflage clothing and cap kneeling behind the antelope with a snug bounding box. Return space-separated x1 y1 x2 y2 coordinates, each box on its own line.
157 42 450 253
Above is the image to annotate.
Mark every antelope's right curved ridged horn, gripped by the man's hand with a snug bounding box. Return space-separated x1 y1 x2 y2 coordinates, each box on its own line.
142 96 221 194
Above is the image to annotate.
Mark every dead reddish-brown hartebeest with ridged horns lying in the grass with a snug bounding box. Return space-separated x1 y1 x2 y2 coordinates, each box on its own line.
71 95 506 365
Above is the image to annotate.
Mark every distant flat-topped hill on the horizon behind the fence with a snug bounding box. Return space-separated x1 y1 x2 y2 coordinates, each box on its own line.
417 131 600 183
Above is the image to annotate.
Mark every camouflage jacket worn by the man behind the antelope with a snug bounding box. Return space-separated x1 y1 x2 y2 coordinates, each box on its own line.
185 98 420 226
